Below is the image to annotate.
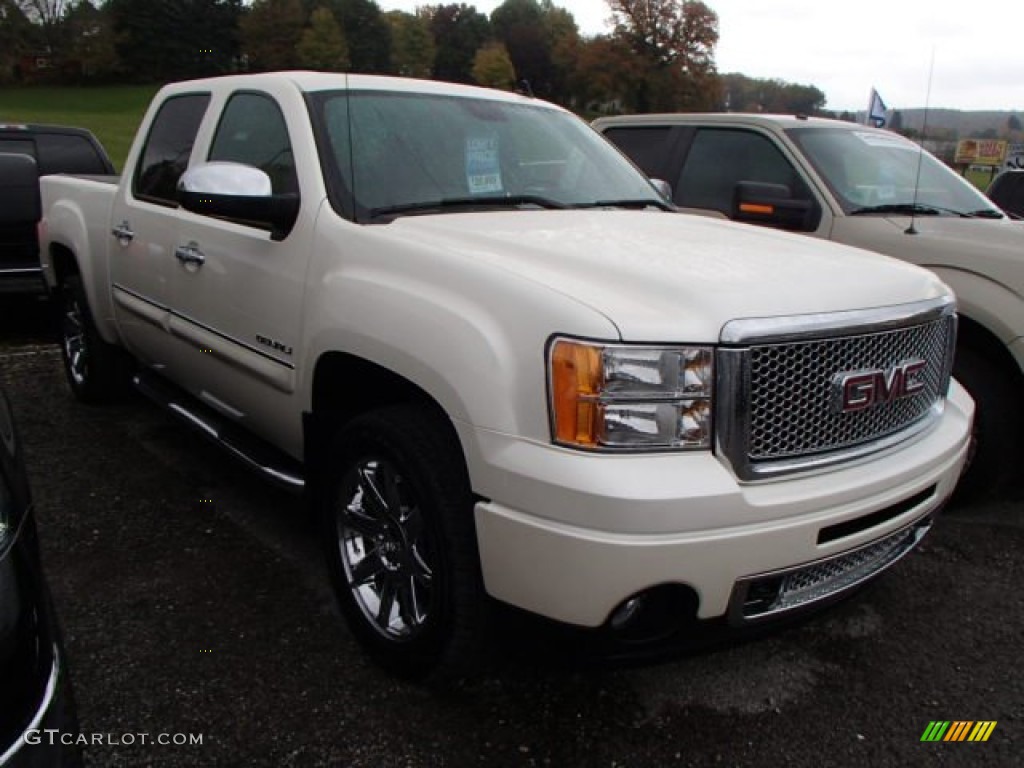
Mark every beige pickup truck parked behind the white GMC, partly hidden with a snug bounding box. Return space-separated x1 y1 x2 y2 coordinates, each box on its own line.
594 114 1024 497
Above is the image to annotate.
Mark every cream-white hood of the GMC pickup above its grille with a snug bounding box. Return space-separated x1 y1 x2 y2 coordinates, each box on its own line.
382 210 949 342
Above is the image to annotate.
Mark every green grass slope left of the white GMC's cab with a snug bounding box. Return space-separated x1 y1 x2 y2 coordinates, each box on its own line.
0 85 159 171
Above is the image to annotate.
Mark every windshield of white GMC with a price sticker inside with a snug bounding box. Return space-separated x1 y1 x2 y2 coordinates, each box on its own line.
310 91 666 222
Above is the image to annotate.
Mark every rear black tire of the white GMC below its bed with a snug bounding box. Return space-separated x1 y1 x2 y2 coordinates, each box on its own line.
58 274 129 403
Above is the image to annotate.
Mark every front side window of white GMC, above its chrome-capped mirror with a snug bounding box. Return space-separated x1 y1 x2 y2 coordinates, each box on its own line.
209 93 299 195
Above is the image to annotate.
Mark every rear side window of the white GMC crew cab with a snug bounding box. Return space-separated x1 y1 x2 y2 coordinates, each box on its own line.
132 93 210 205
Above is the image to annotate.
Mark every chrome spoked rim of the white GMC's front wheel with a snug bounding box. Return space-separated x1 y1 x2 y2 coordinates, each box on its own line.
335 459 436 641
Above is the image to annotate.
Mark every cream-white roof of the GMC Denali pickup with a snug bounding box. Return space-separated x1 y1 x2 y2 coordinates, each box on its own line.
161 71 561 110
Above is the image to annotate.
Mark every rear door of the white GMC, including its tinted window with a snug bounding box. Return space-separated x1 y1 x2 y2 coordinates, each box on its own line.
103 93 210 372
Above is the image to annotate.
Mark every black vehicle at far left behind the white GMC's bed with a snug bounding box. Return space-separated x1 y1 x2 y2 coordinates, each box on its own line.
0 123 114 293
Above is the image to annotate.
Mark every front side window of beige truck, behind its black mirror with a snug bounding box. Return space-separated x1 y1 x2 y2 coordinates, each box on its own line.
675 128 811 215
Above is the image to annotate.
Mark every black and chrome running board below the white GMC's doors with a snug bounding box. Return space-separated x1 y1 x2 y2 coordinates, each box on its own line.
132 371 305 494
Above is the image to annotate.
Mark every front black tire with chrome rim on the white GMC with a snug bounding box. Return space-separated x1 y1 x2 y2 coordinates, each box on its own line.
317 404 485 681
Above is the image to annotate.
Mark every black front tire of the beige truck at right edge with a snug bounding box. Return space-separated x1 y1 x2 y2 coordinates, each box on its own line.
953 345 1024 502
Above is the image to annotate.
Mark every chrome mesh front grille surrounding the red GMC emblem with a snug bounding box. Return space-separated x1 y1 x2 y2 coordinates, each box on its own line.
716 300 955 479
